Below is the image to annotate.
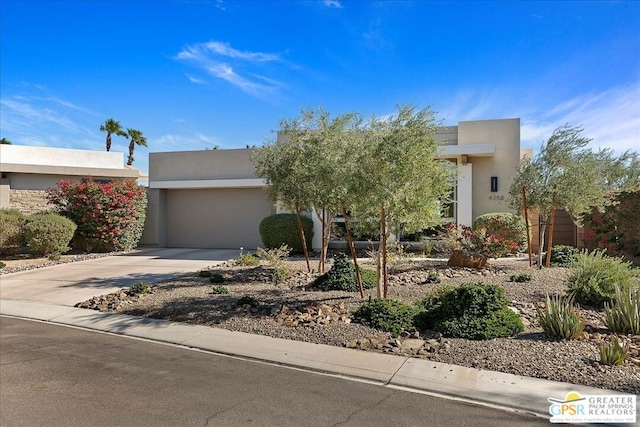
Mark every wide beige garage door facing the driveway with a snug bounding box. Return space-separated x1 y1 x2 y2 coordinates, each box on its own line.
166 188 275 249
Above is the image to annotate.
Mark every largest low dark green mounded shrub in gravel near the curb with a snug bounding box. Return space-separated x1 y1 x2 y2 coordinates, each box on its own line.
416 282 524 339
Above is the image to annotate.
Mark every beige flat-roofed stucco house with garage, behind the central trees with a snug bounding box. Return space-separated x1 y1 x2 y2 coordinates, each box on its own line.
141 119 532 248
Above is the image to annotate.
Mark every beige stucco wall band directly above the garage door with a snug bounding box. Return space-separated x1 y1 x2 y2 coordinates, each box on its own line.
149 148 256 184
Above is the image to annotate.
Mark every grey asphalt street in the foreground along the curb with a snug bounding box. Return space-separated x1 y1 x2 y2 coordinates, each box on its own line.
0 317 549 427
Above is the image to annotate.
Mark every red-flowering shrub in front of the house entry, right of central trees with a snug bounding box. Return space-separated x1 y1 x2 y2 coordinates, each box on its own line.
449 224 519 258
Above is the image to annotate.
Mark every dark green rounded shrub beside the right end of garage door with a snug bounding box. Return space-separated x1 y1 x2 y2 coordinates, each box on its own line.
258 213 313 254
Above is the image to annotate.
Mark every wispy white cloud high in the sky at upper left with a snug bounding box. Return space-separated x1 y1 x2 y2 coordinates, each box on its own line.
175 41 284 97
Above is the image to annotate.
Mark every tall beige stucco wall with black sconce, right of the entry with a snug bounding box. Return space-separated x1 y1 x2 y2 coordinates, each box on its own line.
458 119 520 222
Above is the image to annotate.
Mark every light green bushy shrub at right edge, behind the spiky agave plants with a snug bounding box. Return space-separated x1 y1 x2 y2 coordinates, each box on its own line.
567 250 640 308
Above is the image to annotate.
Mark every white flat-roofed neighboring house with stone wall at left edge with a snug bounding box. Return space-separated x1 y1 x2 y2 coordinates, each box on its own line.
0 144 142 214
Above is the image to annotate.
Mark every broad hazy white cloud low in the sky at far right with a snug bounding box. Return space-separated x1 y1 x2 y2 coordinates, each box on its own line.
434 82 640 153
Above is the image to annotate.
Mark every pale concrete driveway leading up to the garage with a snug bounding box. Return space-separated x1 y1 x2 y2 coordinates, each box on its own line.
0 248 238 306
